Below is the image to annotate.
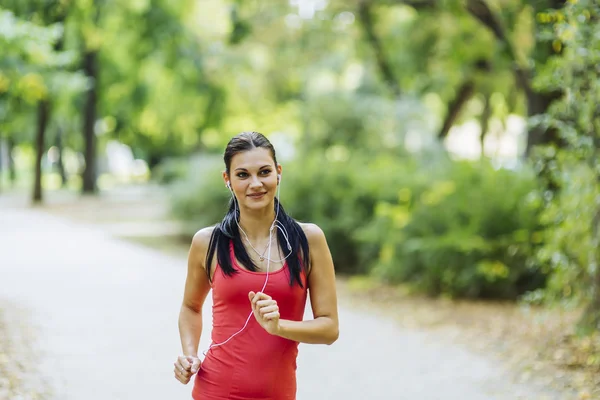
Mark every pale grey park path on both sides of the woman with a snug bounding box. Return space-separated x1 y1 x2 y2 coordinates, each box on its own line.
0 198 562 400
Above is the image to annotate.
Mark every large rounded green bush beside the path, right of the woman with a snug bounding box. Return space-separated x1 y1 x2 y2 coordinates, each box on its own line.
362 162 545 298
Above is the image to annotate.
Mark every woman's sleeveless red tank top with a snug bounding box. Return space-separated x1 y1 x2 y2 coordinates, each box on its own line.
192 245 307 400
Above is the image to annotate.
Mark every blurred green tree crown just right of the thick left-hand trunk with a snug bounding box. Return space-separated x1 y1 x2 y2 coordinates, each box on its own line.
95 0 226 167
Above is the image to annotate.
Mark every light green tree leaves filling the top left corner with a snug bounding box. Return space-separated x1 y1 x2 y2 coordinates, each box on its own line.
0 2 89 153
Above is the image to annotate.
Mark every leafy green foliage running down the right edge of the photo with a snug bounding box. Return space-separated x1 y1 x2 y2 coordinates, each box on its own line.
527 0 600 320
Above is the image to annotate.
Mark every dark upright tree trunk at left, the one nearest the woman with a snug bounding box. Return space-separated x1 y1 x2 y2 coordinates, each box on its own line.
82 51 98 193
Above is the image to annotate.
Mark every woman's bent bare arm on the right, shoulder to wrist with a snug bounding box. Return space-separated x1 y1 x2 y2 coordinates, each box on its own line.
276 224 339 345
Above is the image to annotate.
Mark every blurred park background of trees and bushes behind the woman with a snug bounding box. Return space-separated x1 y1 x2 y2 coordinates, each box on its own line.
0 0 600 398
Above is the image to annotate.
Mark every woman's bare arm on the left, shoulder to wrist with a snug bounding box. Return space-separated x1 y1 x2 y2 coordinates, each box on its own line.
179 228 212 357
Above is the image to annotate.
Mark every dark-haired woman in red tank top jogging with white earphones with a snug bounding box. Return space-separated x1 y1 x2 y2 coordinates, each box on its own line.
174 132 338 400
